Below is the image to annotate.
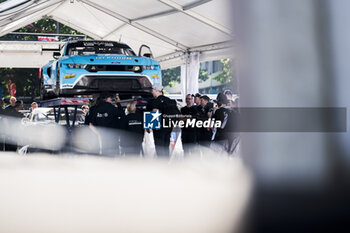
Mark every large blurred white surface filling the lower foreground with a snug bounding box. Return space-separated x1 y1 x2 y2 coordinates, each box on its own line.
0 153 251 233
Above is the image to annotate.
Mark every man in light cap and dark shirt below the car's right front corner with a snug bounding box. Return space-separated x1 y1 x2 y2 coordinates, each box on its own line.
152 83 172 157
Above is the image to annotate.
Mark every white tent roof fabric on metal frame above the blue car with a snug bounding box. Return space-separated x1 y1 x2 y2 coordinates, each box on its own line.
0 0 232 68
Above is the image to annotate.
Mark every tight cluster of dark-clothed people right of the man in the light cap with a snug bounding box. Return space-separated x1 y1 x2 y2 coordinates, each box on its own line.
181 90 239 155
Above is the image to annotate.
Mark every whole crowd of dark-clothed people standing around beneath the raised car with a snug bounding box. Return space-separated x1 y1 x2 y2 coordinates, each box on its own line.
0 84 238 157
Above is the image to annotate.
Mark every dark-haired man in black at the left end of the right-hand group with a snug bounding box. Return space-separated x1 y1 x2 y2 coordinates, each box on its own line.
181 94 197 155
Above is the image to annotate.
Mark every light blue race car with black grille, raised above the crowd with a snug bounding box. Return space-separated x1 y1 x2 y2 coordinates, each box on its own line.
40 40 162 99
